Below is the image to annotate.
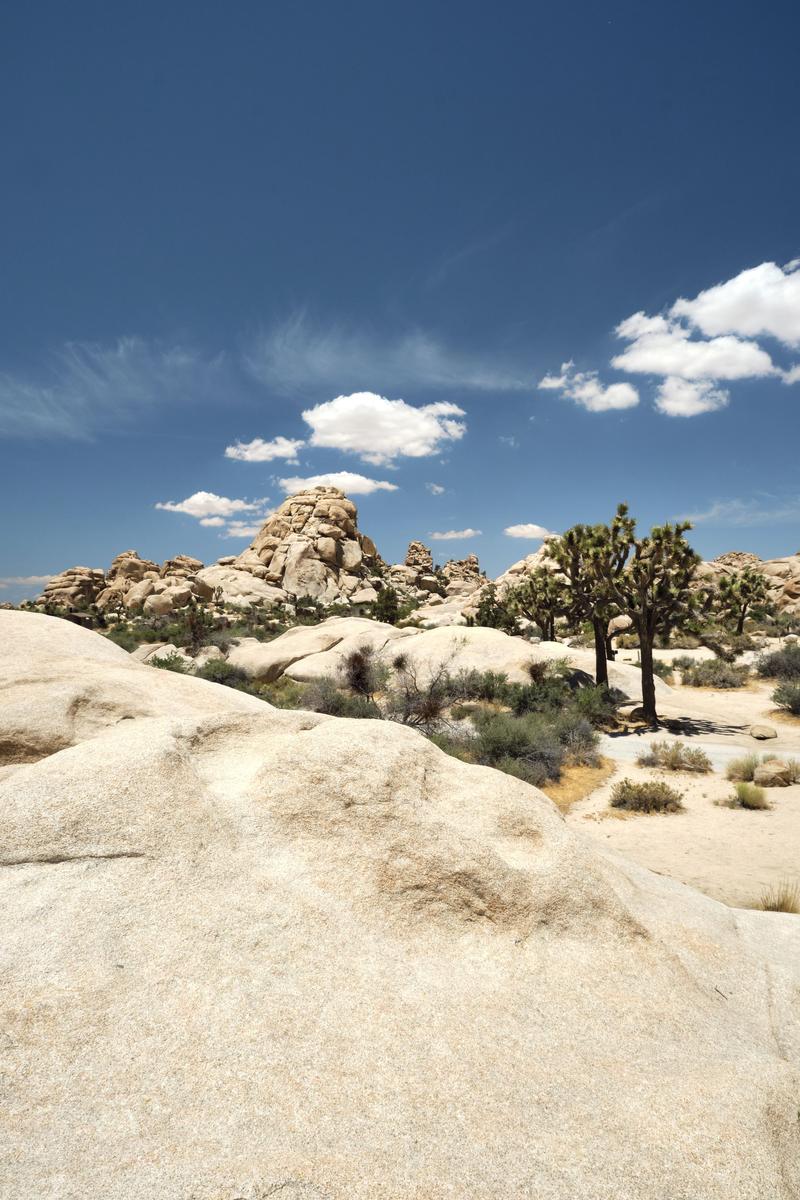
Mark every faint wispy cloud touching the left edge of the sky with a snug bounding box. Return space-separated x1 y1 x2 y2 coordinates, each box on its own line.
0 337 226 438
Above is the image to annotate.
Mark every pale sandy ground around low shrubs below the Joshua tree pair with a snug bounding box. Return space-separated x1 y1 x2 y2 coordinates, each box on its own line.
566 662 800 907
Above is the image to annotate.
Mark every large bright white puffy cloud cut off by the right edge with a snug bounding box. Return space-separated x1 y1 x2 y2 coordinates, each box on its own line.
670 259 800 347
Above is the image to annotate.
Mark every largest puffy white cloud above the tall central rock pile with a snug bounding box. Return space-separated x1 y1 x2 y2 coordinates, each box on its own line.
302 391 467 466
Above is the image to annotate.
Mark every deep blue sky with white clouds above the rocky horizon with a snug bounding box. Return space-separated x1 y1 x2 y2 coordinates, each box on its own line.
0 0 800 600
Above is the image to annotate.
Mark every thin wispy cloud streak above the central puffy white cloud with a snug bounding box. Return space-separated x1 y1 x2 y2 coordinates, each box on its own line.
246 313 530 391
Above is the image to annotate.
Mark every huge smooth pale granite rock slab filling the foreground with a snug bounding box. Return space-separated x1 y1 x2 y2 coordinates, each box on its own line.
0 611 800 1200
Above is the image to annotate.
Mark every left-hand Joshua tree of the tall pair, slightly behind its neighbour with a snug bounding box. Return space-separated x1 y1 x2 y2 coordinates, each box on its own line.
548 504 636 685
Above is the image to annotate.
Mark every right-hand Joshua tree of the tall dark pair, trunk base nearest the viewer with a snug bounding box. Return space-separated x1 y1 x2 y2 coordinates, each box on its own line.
608 521 700 725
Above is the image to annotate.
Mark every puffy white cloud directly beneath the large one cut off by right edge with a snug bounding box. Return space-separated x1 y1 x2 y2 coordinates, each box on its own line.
612 312 777 379
